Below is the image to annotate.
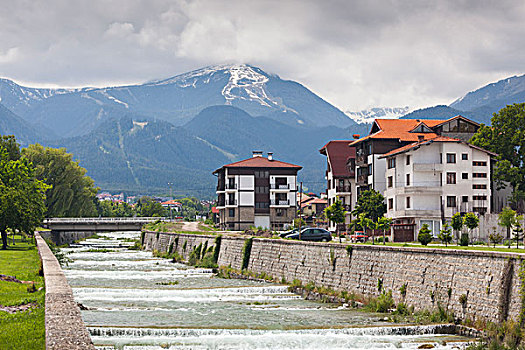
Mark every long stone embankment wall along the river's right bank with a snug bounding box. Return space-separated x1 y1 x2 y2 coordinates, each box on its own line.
144 232 525 321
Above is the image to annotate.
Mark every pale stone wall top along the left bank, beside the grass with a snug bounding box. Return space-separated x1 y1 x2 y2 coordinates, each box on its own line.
35 233 95 350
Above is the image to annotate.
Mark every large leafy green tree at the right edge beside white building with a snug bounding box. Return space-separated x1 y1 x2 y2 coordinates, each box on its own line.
470 103 525 212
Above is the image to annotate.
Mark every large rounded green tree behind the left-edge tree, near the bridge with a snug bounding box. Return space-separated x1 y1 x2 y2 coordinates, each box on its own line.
22 144 98 217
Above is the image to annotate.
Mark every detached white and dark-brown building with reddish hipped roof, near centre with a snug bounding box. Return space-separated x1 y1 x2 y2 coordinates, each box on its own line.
213 151 302 230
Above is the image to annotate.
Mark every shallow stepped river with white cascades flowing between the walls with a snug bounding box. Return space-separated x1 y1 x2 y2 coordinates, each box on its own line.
64 232 466 350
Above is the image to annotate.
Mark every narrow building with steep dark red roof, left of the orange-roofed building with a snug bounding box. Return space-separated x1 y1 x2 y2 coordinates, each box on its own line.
319 140 357 232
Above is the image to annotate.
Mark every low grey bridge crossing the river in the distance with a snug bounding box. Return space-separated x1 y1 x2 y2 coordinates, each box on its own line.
42 217 162 245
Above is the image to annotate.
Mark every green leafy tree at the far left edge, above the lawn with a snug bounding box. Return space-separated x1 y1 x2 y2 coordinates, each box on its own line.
0 137 49 249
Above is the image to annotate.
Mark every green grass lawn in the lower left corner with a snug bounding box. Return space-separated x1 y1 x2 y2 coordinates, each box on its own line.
0 237 45 350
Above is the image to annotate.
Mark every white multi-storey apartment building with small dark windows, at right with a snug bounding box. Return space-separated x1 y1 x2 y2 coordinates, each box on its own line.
381 136 496 241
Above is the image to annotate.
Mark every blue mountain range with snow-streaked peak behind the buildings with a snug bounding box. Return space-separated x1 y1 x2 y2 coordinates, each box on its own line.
0 64 525 196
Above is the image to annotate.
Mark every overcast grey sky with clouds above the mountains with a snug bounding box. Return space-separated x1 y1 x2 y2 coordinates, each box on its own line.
0 0 525 110
